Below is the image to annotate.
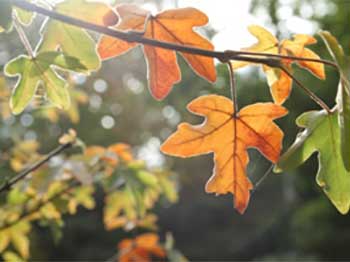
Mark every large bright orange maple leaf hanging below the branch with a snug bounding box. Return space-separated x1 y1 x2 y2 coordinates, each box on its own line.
161 95 287 213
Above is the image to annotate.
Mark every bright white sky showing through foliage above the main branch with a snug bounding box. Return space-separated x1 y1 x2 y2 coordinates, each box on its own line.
46 0 332 51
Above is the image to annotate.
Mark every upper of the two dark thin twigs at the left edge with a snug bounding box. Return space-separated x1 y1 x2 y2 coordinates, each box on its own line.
0 143 72 193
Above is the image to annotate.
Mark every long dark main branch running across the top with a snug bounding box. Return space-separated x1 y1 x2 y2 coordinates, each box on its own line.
12 0 337 67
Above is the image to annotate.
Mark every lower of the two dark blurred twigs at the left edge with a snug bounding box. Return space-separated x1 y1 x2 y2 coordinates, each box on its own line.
0 180 80 232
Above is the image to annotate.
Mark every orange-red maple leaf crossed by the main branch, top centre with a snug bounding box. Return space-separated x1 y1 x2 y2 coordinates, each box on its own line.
98 5 216 100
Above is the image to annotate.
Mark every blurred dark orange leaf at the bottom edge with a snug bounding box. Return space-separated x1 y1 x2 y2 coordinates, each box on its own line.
118 233 166 262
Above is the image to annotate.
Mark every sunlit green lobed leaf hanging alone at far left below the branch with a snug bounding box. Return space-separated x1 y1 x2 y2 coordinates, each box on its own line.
5 52 86 114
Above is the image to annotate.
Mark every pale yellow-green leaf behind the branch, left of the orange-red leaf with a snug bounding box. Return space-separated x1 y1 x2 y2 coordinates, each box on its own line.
38 0 118 72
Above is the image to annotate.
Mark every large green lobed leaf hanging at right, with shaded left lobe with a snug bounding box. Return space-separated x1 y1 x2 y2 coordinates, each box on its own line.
275 111 350 214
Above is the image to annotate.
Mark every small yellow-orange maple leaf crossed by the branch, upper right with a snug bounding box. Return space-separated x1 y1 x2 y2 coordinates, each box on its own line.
232 25 325 105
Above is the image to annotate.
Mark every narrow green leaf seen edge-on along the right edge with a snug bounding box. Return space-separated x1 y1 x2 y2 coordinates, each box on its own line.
320 31 350 171
